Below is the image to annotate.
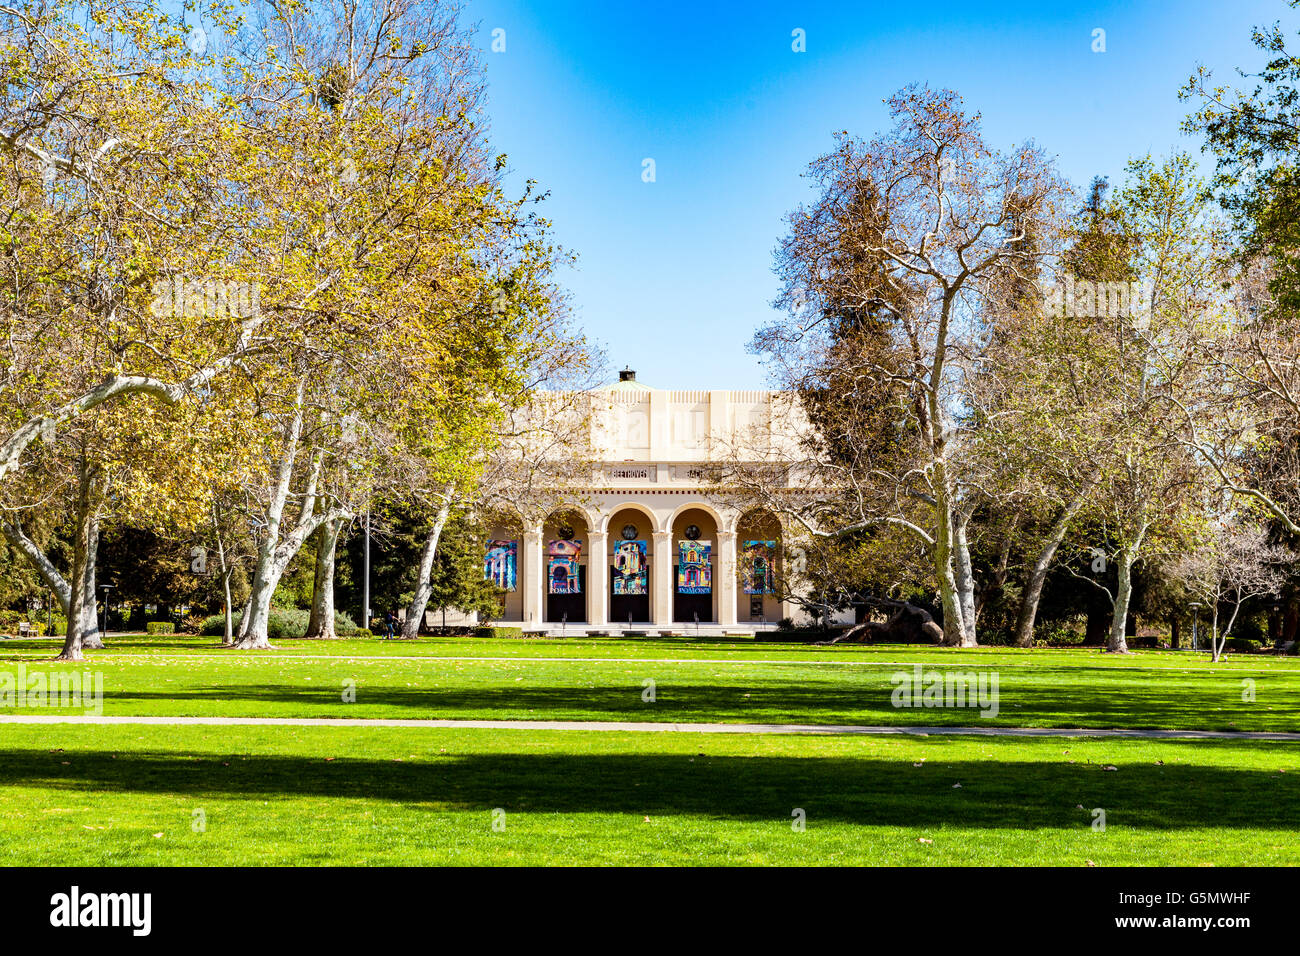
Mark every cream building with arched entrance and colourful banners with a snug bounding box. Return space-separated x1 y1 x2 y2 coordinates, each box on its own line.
489 371 798 633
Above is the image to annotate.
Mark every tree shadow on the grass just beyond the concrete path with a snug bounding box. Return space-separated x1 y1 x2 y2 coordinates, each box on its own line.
83 678 1300 732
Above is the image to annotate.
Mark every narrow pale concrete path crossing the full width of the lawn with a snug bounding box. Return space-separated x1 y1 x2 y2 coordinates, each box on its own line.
0 714 1300 743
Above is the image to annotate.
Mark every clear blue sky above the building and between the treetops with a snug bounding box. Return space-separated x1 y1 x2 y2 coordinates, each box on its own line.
467 0 1300 389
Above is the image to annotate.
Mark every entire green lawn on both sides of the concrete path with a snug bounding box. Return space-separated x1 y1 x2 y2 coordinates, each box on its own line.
0 637 1300 866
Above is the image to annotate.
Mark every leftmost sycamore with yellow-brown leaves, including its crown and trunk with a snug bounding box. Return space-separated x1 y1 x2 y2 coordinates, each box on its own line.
0 1 330 659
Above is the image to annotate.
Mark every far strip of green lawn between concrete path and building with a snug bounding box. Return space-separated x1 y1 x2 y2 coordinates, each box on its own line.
0 639 1300 731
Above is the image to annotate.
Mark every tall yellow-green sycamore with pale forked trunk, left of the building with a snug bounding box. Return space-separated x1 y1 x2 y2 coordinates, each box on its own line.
209 3 590 648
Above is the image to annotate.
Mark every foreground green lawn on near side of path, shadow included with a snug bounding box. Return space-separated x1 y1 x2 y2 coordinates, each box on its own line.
0 726 1300 866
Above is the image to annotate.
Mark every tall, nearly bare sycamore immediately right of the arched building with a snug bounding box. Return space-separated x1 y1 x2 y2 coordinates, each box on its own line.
740 87 1069 645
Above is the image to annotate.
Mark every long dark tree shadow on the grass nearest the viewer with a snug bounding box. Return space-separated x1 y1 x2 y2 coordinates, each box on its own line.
0 737 1300 830
